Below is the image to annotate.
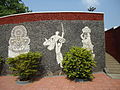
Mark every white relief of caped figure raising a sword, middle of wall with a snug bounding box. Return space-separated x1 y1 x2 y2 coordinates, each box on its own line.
43 23 65 68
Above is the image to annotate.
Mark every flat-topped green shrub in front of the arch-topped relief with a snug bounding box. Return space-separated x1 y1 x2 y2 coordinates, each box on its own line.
7 52 42 81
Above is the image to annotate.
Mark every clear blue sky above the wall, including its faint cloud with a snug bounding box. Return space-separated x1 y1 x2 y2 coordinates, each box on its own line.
22 0 120 30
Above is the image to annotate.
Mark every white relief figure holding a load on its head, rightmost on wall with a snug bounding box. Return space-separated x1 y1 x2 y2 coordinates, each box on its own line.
81 26 95 57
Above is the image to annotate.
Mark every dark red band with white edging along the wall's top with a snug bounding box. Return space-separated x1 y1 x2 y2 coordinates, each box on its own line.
0 11 104 25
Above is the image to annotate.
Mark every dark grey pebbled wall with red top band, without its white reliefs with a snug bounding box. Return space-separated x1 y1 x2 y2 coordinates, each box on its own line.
0 12 105 75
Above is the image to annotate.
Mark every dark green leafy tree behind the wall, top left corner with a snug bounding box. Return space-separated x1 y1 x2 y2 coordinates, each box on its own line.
0 0 31 16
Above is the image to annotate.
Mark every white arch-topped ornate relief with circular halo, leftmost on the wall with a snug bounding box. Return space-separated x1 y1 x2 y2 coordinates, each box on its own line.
8 25 30 57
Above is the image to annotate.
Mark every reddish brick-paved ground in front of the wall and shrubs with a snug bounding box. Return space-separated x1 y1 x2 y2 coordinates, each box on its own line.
0 73 120 90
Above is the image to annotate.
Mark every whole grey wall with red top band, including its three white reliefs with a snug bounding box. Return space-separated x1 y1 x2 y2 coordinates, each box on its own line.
0 13 105 75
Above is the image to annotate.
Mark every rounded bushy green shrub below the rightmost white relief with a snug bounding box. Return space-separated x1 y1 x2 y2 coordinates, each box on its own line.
62 47 96 80
